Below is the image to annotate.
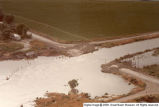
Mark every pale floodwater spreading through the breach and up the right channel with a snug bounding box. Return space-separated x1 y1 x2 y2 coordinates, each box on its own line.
0 38 159 107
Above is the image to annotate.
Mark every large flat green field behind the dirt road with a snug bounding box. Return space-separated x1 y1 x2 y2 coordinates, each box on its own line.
0 0 159 41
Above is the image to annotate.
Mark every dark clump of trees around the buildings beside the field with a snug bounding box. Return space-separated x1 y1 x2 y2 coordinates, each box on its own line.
0 9 31 40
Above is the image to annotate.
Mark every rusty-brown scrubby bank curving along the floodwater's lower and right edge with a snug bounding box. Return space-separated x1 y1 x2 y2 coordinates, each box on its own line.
35 61 146 107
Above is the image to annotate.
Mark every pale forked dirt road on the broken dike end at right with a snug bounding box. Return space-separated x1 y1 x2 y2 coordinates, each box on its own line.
103 61 159 103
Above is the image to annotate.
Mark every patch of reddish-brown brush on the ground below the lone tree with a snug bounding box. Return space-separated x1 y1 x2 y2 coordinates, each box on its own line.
35 93 95 107
